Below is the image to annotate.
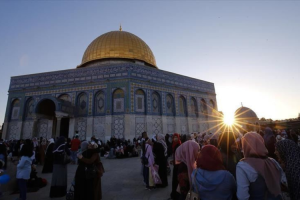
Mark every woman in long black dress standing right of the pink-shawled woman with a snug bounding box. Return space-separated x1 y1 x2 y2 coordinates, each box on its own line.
153 134 168 187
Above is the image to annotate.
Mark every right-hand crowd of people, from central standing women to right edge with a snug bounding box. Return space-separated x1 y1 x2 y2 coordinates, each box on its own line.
141 127 300 200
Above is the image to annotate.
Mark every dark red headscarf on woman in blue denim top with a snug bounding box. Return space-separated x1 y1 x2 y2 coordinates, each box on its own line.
197 145 225 171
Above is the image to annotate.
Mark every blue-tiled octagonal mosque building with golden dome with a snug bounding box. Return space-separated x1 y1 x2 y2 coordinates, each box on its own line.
2 28 217 141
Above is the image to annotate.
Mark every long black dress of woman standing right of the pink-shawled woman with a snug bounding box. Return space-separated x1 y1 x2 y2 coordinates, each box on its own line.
153 142 168 187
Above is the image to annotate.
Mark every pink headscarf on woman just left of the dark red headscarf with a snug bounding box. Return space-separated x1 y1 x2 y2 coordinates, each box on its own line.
175 140 200 182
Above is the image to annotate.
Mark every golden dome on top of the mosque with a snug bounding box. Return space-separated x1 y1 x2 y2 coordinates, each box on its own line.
79 29 157 68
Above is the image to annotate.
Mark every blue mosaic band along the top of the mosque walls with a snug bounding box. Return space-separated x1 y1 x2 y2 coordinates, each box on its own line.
10 63 215 96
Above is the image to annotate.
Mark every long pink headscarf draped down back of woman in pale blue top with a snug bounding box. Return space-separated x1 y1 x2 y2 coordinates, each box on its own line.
242 132 281 196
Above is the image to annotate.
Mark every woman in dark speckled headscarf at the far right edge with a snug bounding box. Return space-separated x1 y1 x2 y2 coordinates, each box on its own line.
275 140 300 200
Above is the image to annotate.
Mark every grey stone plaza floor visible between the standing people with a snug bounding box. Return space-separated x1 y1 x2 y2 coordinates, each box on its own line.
2 157 172 200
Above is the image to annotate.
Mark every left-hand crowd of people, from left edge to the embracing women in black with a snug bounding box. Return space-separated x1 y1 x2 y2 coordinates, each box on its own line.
0 135 104 200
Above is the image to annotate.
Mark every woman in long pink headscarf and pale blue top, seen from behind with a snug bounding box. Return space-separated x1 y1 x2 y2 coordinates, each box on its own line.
236 132 281 200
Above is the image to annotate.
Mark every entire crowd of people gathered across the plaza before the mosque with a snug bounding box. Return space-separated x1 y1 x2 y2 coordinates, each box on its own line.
0 128 300 200
